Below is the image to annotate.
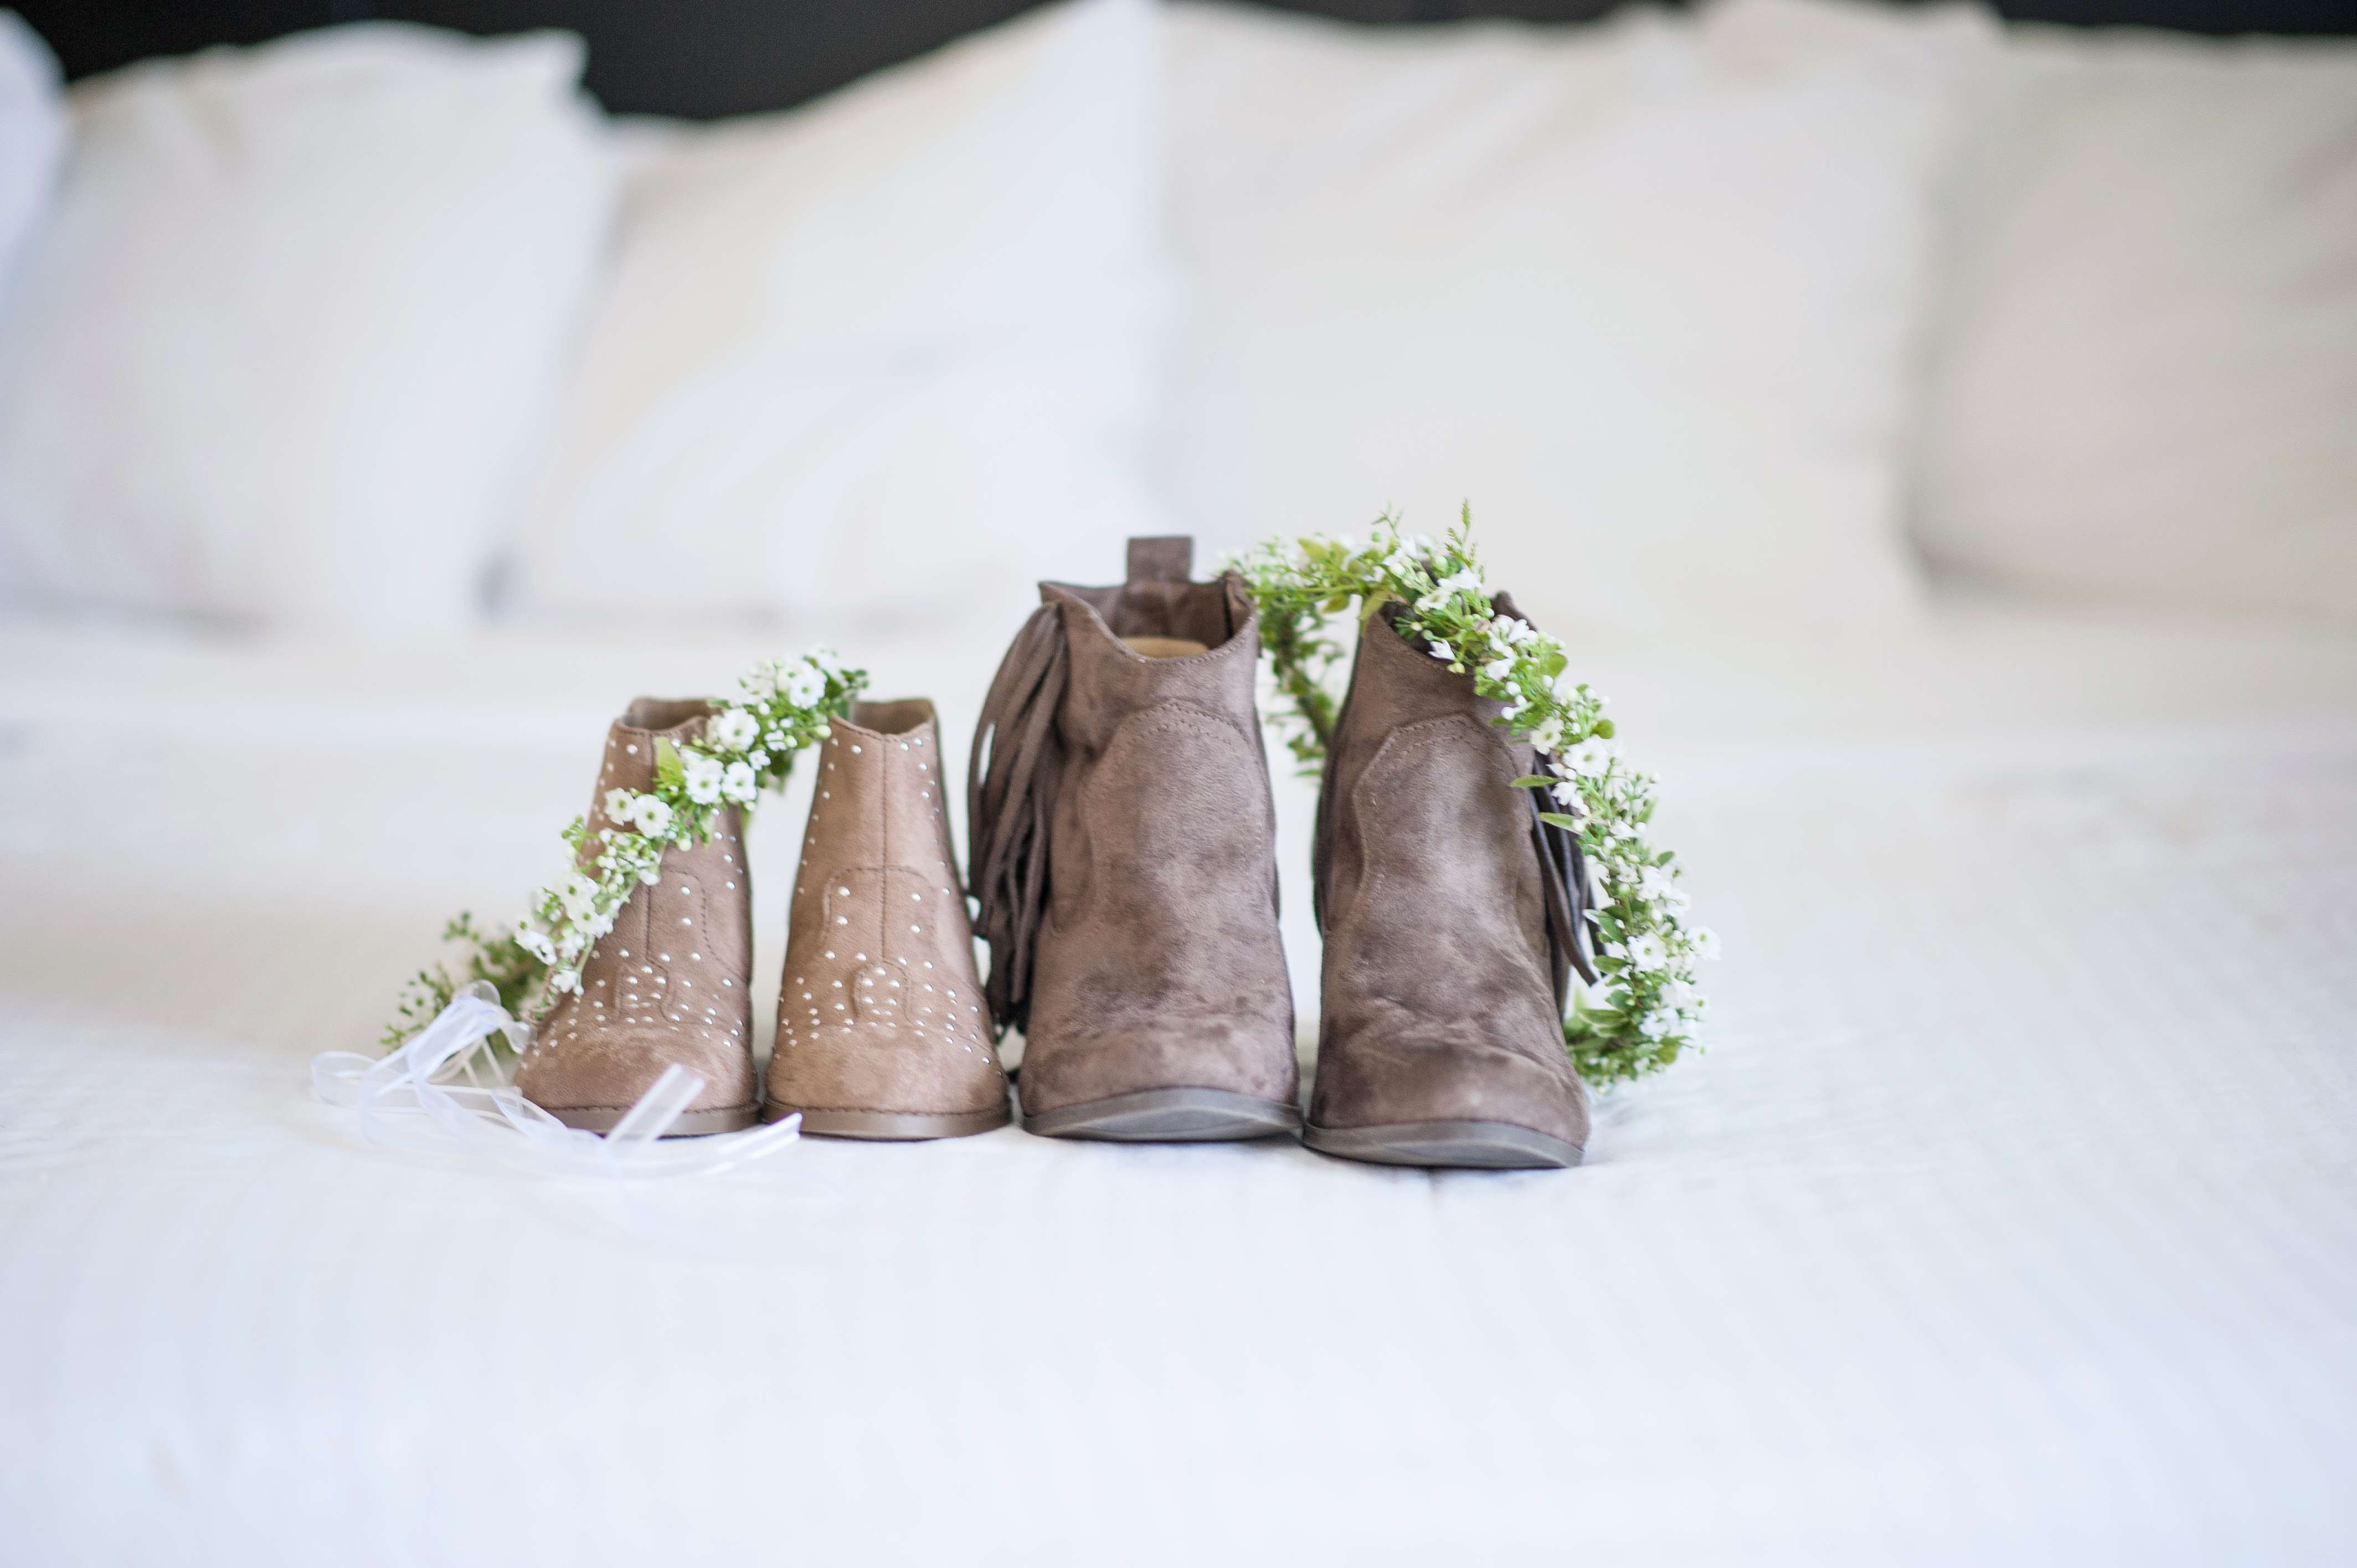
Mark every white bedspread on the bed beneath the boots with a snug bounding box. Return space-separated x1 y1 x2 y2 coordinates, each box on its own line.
0 606 2357 1568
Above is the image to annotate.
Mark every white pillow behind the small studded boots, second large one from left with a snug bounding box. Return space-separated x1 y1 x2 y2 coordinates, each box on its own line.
518 0 1167 641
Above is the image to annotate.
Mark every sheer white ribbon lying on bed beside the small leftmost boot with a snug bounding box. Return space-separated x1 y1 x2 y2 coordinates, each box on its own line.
311 981 801 1177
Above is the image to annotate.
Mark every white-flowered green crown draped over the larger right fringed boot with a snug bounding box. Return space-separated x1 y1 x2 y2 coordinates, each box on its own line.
1226 507 1718 1085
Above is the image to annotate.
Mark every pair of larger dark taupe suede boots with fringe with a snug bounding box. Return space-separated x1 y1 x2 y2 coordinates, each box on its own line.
966 538 1589 1167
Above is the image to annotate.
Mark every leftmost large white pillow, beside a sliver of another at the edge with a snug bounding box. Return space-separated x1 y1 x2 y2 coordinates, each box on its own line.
0 24 613 637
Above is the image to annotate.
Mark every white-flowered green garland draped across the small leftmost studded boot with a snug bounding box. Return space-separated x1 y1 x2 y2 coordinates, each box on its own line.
384 648 867 1049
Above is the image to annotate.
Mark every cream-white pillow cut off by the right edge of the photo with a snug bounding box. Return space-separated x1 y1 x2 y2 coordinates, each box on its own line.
1916 28 2357 625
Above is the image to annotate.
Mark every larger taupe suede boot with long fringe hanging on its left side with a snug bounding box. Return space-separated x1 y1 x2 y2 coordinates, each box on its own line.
966 538 1301 1141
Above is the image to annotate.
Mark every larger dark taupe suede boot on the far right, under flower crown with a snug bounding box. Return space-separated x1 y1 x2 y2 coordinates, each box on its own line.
1301 596 1589 1167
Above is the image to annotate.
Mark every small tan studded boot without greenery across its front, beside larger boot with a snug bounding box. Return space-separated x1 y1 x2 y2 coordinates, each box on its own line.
766 700 1009 1139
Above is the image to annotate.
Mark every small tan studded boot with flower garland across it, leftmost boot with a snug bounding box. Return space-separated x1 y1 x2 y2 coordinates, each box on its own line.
516 698 756 1134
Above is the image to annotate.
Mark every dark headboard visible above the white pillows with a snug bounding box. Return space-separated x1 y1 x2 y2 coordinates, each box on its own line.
9 0 2357 118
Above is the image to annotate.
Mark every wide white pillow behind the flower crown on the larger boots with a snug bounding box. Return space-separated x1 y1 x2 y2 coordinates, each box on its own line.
1171 0 1985 637
